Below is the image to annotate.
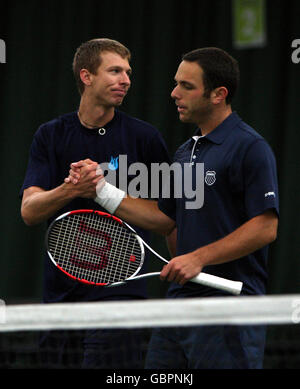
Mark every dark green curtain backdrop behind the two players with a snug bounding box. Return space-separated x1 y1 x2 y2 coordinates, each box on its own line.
0 0 300 303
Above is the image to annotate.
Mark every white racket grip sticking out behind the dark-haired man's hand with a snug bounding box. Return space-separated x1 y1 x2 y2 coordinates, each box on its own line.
190 273 243 295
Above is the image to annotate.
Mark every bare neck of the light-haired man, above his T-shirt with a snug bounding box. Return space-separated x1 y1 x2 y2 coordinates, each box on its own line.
78 98 115 128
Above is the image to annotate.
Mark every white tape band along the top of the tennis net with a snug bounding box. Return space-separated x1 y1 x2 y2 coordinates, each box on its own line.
0 295 300 332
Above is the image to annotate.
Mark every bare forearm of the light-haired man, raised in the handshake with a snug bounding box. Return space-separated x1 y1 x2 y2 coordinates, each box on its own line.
21 184 75 226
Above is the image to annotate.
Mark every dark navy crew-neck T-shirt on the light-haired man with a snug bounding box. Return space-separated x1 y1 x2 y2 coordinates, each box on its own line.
20 110 170 302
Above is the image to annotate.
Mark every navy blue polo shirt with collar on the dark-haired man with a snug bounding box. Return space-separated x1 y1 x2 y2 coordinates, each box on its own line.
159 112 279 297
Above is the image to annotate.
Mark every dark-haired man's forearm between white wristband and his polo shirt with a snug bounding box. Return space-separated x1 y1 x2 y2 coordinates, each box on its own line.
115 196 175 235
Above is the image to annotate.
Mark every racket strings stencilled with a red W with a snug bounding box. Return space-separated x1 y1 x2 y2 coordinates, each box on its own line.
48 214 143 284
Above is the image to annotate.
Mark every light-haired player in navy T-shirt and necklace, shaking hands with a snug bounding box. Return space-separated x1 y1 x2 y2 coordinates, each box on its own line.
21 39 169 368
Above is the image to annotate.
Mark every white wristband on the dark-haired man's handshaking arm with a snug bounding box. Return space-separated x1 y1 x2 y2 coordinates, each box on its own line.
94 179 126 214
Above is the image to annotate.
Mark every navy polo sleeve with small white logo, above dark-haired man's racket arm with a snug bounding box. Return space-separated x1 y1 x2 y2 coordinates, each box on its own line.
243 140 279 218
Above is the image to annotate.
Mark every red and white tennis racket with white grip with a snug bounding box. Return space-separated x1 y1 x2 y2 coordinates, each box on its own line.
46 210 242 294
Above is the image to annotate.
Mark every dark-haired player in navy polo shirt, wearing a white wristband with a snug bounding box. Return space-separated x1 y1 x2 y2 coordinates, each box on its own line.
67 48 279 369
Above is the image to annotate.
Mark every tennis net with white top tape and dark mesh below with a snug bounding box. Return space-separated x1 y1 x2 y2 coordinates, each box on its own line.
0 294 300 369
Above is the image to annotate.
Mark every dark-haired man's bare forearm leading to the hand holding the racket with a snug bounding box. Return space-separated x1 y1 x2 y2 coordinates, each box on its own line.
193 211 278 266
